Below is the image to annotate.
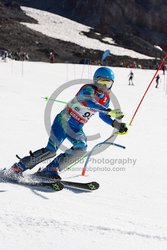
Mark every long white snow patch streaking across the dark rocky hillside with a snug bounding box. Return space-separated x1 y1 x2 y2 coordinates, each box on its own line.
22 7 153 59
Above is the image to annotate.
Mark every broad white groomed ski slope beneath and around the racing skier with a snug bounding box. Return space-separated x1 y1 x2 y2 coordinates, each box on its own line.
0 61 167 250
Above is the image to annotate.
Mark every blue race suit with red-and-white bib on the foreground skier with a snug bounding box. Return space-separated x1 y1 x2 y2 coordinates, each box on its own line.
46 84 113 170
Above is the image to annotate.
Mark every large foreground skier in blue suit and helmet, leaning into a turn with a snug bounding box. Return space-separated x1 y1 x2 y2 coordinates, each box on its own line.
9 67 128 179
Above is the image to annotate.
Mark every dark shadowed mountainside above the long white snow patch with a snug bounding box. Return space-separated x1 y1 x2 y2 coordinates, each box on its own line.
13 0 167 45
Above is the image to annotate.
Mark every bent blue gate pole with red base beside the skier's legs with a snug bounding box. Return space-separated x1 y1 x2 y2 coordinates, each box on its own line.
81 133 126 176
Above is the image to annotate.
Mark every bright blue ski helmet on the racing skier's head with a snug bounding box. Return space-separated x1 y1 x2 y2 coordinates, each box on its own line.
93 67 115 82
